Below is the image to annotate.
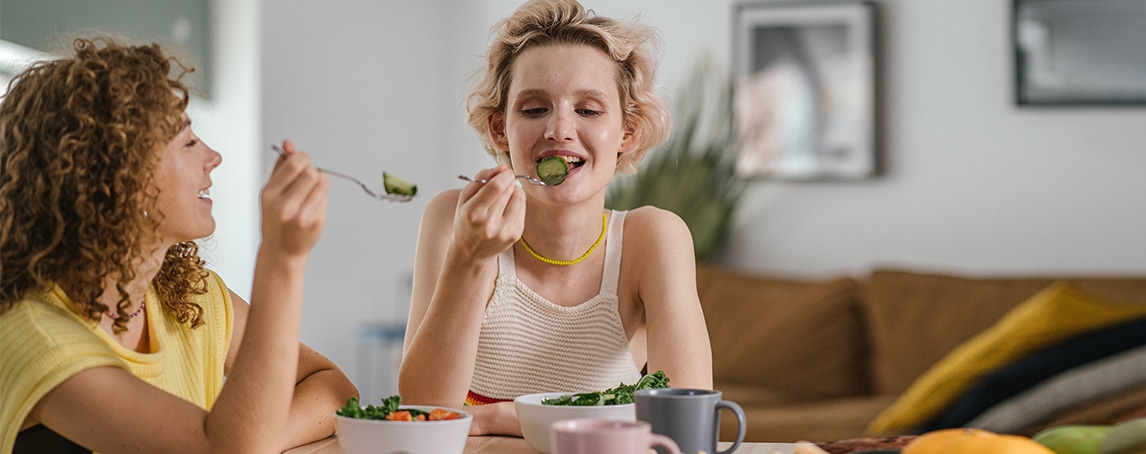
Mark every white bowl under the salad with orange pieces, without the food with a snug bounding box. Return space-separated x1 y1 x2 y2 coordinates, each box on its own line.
335 405 473 454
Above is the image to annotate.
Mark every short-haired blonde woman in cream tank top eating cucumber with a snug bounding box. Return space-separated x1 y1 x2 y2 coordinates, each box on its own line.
399 0 712 435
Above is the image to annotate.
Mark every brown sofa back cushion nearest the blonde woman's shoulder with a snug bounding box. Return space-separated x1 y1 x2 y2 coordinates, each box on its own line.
697 265 869 400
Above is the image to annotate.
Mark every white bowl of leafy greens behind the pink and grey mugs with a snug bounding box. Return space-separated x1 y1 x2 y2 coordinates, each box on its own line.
513 370 668 454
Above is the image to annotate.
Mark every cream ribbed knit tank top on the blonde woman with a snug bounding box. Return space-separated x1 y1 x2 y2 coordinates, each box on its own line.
470 211 641 400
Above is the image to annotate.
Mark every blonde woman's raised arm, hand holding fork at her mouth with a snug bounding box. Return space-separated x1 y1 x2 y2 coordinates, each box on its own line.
398 165 525 407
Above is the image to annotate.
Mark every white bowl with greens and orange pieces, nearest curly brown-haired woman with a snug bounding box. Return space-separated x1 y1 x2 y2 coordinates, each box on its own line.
335 396 473 454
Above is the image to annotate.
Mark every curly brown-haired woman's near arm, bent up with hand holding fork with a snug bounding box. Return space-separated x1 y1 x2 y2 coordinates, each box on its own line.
30 143 329 453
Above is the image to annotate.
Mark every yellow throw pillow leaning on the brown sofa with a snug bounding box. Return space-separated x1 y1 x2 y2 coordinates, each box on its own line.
868 282 1146 433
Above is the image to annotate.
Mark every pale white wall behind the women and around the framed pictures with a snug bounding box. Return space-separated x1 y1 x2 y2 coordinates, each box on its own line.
250 0 1146 396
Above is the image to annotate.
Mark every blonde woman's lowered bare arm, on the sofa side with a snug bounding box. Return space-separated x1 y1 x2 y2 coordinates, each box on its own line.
623 206 713 389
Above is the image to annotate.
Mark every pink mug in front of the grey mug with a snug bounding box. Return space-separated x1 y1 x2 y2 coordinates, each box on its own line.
549 420 681 454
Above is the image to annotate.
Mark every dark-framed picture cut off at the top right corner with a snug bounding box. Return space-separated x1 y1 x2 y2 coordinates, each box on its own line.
1011 0 1146 105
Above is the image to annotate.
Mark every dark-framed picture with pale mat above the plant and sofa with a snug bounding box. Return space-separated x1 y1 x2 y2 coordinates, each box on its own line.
732 0 878 180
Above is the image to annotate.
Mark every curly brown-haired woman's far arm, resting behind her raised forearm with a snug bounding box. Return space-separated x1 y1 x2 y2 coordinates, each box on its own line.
226 292 359 451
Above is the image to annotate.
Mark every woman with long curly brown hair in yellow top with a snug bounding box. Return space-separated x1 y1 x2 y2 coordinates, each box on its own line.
0 39 356 453
